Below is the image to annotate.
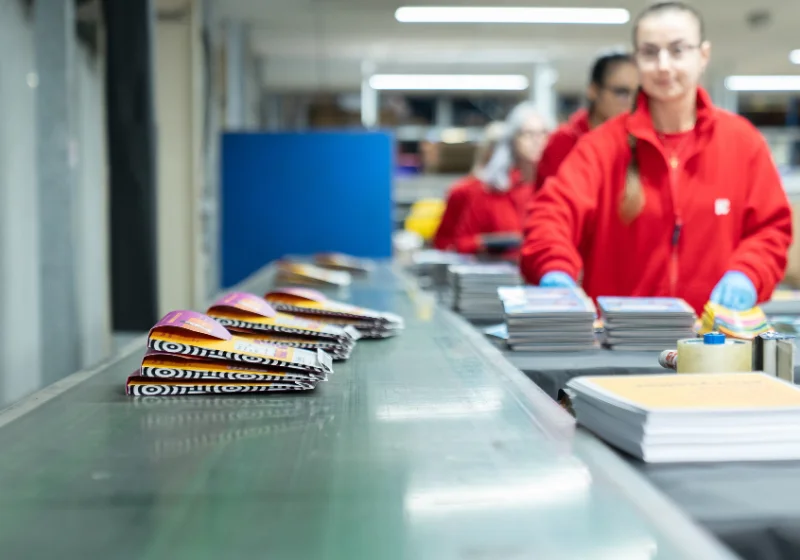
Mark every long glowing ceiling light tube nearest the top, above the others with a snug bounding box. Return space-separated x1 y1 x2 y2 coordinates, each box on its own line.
394 6 631 25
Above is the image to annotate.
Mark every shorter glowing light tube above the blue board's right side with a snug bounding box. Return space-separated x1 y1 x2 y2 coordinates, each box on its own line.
369 74 530 91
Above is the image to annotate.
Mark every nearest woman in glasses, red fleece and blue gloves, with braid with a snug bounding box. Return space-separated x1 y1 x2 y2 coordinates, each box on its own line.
521 2 792 313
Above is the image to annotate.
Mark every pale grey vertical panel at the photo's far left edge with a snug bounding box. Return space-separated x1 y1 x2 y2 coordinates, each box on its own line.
0 0 42 405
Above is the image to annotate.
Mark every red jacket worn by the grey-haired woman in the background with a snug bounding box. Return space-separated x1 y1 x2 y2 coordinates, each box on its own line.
454 170 533 256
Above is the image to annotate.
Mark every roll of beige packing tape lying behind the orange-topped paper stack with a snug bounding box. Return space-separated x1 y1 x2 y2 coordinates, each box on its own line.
678 338 753 373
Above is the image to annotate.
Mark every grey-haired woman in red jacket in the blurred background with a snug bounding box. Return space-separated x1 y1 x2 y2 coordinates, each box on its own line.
454 102 550 257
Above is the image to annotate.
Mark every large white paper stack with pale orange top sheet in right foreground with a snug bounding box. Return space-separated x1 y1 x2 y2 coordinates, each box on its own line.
567 372 800 463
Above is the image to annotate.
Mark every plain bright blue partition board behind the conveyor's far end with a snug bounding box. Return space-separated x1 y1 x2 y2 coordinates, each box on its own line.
221 131 394 287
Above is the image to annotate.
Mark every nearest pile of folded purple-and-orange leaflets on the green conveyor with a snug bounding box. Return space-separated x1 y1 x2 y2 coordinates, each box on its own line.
126 311 333 397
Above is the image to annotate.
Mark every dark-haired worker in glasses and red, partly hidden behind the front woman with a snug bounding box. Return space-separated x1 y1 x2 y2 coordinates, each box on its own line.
536 52 639 190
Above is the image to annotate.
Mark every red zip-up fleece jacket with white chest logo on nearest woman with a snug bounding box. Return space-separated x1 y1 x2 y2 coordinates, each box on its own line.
521 89 792 313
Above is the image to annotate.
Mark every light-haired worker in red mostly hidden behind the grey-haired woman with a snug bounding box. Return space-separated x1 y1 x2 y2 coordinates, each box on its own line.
433 122 505 251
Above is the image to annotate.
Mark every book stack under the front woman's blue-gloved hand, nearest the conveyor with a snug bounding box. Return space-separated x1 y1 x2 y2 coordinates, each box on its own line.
498 286 597 352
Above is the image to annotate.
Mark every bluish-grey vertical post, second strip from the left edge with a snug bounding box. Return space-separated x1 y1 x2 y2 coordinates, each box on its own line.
34 0 81 383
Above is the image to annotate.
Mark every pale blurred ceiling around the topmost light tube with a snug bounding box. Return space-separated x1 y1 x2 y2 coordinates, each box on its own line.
216 0 800 91
